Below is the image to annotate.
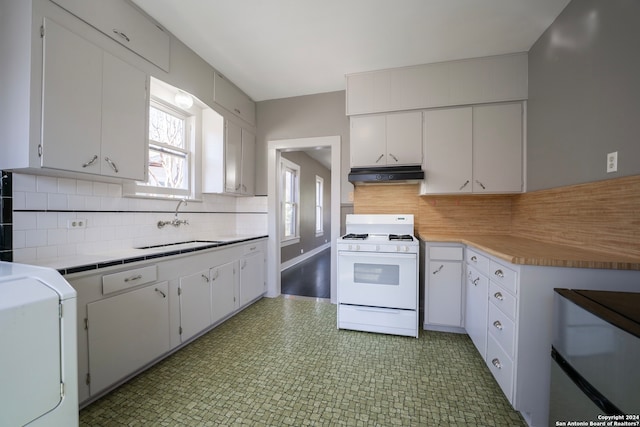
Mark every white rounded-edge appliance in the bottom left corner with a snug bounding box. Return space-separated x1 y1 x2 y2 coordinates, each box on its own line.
0 262 78 427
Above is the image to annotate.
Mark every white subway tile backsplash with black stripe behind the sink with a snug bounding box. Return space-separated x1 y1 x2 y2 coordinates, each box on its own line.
13 174 267 262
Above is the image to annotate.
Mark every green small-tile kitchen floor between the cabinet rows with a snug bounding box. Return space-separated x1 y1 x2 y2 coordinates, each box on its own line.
80 297 526 427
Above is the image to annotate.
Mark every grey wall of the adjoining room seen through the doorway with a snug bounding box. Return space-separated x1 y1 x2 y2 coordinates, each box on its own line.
280 151 331 262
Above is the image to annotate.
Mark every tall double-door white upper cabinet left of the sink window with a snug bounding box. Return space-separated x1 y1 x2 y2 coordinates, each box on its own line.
41 19 148 180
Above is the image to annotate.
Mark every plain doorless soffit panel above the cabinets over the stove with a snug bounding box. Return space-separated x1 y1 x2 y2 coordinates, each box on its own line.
346 53 528 115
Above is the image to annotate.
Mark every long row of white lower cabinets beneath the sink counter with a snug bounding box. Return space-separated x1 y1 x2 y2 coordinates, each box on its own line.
70 239 266 406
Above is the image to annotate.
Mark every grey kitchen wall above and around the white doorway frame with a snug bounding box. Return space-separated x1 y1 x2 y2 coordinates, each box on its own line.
256 91 353 202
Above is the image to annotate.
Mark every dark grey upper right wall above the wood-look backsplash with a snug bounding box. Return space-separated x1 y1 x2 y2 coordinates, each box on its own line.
527 0 640 191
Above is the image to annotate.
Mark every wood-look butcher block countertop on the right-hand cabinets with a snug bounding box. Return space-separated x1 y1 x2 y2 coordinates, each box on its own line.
419 234 640 270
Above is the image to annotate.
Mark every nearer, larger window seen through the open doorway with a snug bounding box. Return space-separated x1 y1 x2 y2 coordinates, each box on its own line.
280 158 300 246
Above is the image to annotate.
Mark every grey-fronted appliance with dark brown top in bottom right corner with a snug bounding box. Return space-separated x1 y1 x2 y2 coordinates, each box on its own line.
549 289 640 425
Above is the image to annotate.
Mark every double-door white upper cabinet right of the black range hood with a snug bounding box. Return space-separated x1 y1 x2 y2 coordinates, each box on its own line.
421 102 524 194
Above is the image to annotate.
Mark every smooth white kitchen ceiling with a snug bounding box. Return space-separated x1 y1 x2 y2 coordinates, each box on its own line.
132 0 570 101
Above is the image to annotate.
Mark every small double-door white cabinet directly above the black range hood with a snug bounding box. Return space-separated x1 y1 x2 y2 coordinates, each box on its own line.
350 111 422 167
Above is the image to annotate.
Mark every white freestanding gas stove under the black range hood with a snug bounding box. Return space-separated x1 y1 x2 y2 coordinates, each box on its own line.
337 214 420 338
